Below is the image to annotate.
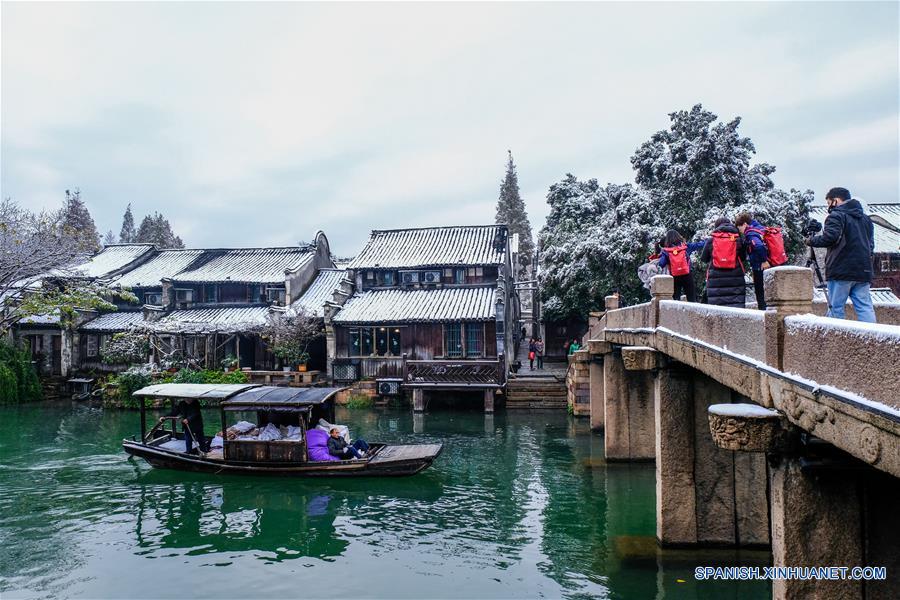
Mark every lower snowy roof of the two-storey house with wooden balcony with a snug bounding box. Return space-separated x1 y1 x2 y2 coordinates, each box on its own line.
334 286 496 324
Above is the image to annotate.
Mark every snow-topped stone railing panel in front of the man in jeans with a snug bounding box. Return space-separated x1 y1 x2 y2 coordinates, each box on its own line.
783 315 900 409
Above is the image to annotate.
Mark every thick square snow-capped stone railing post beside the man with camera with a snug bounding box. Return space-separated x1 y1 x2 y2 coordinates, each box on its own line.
763 267 813 370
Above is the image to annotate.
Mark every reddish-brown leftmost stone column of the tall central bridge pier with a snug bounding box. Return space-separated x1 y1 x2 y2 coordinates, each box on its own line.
654 365 697 546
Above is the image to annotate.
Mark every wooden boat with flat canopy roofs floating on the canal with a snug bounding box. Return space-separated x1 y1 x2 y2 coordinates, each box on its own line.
122 383 443 477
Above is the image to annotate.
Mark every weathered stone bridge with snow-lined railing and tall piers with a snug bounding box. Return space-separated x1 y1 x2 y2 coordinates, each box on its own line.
569 267 900 599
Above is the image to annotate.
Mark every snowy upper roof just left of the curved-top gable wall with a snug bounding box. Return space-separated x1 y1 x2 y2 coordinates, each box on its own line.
171 246 315 283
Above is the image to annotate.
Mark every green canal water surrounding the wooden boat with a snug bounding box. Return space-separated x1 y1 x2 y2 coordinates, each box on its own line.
0 403 770 600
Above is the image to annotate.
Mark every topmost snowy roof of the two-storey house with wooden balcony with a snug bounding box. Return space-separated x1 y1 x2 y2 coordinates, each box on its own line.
348 225 507 269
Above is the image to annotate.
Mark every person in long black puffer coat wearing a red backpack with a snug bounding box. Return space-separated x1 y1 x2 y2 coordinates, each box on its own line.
700 217 747 308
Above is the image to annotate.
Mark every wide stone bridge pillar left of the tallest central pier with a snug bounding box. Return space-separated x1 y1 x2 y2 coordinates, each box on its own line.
603 347 658 461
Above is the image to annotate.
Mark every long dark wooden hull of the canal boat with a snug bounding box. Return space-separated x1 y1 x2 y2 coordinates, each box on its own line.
122 440 443 477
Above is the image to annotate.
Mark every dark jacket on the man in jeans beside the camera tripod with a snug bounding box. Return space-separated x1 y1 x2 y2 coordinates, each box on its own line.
810 200 875 283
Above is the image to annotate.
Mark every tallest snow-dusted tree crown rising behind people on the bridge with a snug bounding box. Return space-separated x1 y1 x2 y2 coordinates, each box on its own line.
631 104 775 238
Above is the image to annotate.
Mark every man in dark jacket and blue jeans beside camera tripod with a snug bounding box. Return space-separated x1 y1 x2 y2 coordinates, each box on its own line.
806 188 875 323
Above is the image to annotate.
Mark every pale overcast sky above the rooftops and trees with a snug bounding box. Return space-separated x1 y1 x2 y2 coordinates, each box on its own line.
0 2 900 256
